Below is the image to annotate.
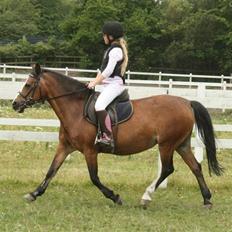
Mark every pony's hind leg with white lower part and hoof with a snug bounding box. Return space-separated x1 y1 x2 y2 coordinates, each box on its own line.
141 145 174 209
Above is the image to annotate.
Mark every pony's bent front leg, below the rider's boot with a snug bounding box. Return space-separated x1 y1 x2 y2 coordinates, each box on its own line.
84 151 122 205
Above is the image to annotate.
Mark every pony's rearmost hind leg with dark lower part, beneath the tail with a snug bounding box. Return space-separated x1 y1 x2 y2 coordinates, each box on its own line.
176 137 212 208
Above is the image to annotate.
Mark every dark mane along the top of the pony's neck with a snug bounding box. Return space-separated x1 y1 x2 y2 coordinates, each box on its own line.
43 69 86 91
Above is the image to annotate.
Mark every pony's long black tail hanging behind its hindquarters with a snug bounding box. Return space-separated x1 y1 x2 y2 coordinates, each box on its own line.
191 101 223 176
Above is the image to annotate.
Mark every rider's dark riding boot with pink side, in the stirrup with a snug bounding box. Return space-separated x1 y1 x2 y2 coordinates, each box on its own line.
96 110 114 147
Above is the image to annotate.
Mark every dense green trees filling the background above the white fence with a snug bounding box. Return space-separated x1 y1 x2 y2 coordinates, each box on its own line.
0 0 232 74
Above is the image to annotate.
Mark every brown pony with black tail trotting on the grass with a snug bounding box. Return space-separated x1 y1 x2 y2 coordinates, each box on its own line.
12 64 222 207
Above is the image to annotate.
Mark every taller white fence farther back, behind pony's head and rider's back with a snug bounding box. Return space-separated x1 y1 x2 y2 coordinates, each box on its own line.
0 65 232 110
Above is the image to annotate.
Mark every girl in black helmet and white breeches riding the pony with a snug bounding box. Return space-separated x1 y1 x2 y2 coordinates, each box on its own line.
88 21 128 147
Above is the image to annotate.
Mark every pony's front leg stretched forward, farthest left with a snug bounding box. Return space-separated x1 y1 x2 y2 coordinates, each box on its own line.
24 142 73 201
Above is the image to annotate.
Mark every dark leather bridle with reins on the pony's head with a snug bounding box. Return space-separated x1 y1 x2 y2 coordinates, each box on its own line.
18 73 89 108
